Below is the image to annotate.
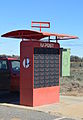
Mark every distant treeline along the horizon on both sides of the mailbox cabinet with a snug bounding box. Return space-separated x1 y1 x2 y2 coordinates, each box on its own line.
0 54 83 62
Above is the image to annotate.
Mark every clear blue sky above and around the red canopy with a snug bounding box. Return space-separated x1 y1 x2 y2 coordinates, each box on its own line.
0 0 83 57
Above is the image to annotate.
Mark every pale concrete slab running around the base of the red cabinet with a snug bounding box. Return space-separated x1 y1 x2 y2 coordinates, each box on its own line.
0 96 83 120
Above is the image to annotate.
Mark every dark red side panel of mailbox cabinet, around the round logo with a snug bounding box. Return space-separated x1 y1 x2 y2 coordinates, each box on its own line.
20 42 33 106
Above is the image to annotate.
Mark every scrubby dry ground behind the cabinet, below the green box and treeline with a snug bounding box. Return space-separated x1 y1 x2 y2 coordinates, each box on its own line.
60 62 83 96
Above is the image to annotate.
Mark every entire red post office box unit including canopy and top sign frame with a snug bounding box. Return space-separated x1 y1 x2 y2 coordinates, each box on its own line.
2 22 78 106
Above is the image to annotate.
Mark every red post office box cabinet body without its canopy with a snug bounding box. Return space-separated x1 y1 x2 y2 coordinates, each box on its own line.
20 41 60 106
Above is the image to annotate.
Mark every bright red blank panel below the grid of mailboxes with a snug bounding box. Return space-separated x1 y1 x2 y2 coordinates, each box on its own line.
33 86 60 106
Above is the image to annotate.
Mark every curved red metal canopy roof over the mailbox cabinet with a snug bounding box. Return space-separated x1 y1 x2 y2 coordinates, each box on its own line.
1 30 78 40
